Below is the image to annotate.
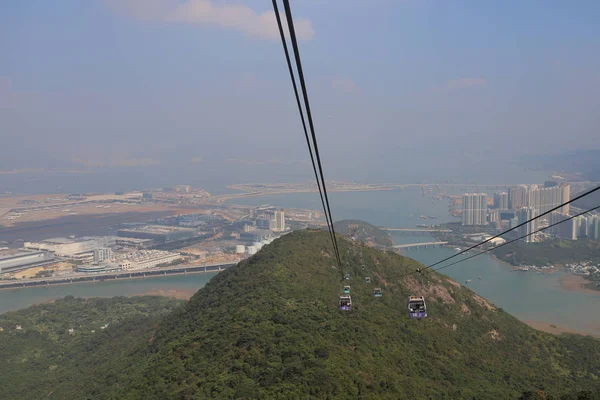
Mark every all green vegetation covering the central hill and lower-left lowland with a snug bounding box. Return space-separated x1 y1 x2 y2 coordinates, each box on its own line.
0 230 600 399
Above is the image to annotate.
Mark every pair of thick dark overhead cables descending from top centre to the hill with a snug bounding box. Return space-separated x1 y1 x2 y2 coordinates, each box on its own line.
273 0 343 274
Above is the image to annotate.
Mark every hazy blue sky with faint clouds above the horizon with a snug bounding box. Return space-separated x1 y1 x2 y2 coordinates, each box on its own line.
0 0 600 178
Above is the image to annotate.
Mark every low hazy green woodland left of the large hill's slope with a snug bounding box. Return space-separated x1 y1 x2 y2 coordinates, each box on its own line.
0 296 183 399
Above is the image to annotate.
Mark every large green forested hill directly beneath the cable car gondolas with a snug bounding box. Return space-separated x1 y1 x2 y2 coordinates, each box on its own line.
119 230 600 399
